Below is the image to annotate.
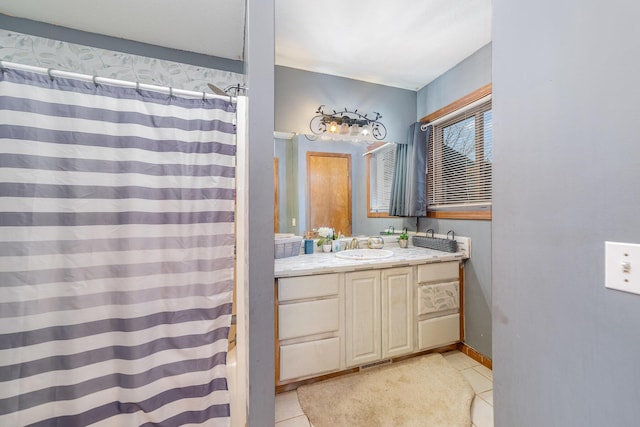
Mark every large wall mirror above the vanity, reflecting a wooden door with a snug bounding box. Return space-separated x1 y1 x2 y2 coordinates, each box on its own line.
274 132 417 235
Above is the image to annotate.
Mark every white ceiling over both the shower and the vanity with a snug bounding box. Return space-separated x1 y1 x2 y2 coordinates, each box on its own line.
0 0 492 90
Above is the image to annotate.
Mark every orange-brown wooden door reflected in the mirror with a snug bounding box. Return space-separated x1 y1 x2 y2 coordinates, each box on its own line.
307 152 351 236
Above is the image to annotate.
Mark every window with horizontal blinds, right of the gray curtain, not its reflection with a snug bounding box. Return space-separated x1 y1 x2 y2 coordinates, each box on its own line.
427 100 493 210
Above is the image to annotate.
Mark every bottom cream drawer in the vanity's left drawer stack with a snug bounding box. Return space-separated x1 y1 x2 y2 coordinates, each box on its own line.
280 337 340 381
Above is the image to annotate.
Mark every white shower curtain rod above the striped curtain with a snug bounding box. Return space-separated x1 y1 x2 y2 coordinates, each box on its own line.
0 61 237 100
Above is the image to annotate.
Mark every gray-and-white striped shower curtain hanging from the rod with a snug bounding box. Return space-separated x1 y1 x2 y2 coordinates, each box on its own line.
0 69 235 427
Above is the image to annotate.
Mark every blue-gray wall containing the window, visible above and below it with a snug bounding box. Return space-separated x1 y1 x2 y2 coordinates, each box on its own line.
418 44 495 357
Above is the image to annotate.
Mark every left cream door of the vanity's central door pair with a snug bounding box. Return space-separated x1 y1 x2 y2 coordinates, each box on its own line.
345 270 382 366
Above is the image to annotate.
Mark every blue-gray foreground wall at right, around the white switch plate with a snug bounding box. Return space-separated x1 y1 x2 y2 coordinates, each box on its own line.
492 0 640 427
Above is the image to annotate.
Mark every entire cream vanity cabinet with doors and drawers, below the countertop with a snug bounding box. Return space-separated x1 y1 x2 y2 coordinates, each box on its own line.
275 260 460 386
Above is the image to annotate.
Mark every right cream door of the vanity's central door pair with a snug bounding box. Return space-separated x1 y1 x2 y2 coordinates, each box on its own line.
382 267 415 359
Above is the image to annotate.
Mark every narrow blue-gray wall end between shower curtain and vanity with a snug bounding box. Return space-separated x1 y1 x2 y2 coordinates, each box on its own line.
245 0 275 426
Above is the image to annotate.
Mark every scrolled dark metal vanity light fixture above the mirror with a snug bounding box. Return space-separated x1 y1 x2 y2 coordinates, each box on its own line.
309 105 387 142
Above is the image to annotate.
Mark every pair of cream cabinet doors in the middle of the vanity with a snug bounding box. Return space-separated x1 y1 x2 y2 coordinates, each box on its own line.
345 267 415 367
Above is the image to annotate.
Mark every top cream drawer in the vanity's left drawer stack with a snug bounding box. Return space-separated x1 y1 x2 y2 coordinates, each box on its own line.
278 274 340 302
